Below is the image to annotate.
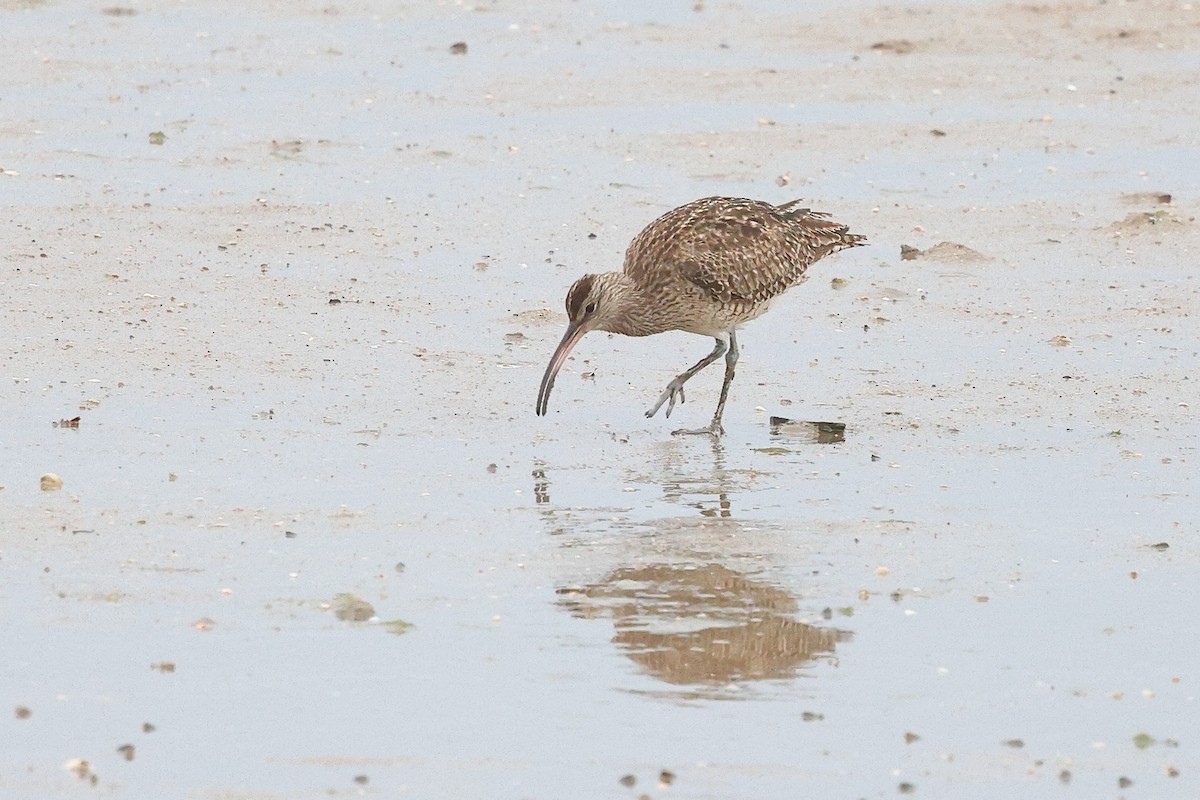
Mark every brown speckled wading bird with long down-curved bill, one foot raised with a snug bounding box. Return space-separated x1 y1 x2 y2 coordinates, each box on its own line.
538 197 865 434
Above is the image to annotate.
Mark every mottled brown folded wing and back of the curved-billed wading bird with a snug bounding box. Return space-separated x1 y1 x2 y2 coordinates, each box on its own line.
625 198 862 303
